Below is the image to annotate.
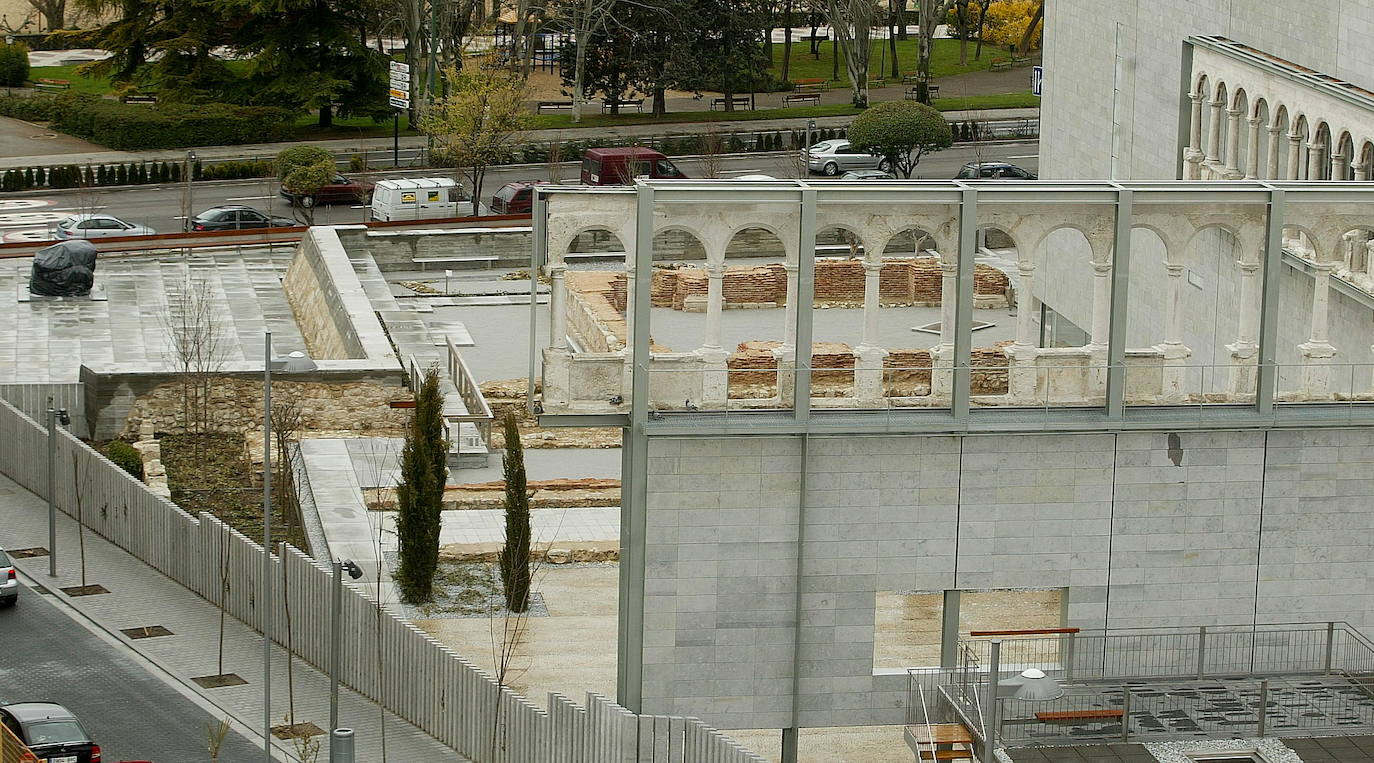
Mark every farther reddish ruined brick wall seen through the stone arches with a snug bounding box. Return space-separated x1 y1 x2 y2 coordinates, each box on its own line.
650 257 1010 312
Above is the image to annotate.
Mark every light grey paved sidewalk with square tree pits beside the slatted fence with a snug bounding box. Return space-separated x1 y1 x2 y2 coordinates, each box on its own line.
0 476 466 763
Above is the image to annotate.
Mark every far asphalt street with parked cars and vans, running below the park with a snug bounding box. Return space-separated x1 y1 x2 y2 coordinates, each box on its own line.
0 142 1040 241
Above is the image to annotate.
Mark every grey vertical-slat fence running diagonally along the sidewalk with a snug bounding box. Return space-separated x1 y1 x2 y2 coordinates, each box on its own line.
0 403 763 763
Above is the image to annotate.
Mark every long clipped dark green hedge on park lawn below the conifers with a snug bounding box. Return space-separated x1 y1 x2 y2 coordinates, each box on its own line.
0 93 293 151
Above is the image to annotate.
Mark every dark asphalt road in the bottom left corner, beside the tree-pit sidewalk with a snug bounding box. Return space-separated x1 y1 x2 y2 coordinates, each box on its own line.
0 588 261 763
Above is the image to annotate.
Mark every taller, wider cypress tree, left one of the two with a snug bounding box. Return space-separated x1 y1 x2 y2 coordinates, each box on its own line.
396 366 448 604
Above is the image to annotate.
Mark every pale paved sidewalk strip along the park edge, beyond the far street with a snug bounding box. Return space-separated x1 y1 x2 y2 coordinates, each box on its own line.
0 104 1040 169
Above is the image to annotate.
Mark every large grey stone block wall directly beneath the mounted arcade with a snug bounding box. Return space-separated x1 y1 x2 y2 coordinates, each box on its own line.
628 429 1374 729
